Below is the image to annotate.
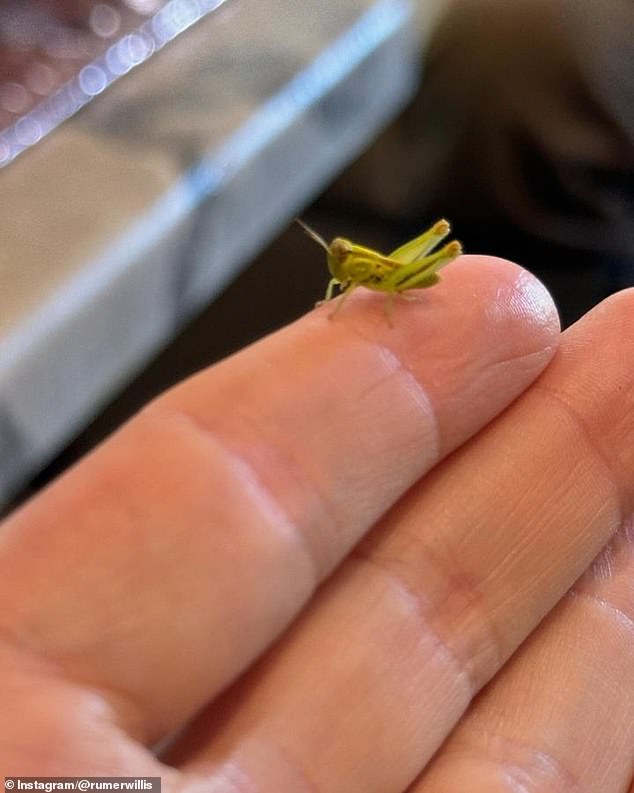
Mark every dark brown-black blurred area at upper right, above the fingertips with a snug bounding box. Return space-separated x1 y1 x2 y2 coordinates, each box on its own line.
320 0 634 325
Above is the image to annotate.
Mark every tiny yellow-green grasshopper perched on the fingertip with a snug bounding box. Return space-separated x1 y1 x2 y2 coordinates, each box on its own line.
297 220 462 325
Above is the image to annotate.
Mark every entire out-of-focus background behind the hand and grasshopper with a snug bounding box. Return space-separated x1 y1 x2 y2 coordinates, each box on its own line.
0 0 634 509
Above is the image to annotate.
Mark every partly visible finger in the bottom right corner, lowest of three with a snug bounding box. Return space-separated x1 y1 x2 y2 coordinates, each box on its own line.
412 520 634 793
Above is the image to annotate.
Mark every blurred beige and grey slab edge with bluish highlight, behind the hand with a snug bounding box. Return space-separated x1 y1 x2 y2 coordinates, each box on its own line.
0 0 419 506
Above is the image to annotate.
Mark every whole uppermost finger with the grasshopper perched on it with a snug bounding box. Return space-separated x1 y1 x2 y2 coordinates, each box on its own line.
0 257 557 738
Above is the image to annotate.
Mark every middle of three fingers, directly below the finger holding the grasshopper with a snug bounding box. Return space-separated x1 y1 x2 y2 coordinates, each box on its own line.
170 291 634 793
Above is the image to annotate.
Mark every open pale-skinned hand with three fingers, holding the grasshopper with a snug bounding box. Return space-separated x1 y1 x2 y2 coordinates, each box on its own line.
0 256 634 793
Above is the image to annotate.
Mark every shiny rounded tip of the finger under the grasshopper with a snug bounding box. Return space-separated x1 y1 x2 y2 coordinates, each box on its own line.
311 255 560 452
